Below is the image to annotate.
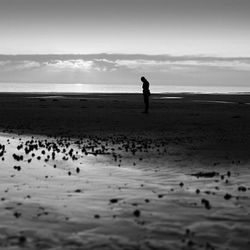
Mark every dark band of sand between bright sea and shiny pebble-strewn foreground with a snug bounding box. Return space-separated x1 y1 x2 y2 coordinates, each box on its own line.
0 94 250 168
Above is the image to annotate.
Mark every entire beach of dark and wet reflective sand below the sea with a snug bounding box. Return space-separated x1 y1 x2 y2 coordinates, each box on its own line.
0 94 250 249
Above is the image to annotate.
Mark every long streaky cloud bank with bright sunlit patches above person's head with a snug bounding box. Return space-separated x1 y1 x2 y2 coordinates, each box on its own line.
0 54 250 73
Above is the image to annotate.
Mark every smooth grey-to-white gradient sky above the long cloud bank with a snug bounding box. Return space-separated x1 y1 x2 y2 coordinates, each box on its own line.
0 0 250 57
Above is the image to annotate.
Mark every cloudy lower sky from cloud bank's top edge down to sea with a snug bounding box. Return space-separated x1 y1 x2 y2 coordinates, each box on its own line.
0 54 250 89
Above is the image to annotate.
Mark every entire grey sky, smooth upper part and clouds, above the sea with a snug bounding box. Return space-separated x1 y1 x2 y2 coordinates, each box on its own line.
0 0 250 91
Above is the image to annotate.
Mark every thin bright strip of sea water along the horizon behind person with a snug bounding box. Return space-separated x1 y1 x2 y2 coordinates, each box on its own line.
0 83 250 93
